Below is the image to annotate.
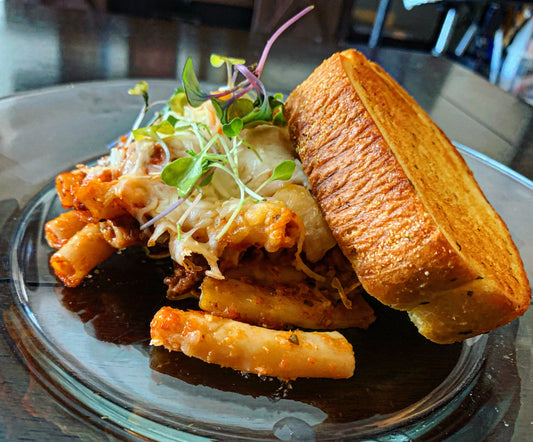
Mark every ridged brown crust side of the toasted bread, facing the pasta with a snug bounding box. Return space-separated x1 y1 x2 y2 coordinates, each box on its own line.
288 52 473 308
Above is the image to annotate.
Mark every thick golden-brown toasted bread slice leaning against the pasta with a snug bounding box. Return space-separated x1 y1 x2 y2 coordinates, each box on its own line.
285 50 531 343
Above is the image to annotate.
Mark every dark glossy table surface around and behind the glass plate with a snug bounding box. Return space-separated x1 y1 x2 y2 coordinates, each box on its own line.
0 1 533 441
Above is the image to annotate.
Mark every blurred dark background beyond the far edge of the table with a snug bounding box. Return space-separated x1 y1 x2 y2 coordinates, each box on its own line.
4 0 533 105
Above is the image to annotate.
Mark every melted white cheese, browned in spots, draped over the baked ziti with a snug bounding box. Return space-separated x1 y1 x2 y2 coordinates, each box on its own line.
106 103 335 279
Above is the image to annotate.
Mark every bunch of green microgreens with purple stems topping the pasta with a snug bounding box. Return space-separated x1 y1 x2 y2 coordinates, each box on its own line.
132 6 313 239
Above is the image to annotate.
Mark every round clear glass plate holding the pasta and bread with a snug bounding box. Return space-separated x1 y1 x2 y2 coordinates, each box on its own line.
0 81 533 441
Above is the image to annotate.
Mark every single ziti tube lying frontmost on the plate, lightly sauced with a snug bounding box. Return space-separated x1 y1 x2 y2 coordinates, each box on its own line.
150 307 355 379
